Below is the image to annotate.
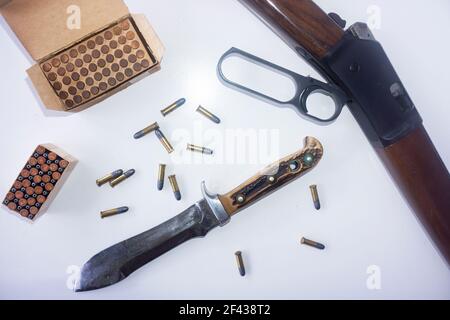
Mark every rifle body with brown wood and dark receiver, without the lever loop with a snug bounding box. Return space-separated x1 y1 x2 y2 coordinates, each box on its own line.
240 0 450 264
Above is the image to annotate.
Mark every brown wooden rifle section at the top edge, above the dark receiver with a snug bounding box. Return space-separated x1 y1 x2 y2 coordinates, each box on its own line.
240 0 344 59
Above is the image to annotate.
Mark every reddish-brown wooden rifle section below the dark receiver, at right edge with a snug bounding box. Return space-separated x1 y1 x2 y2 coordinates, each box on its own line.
377 126 450 265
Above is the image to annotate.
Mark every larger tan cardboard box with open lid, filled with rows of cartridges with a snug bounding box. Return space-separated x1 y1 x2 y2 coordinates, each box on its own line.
0 0 164 112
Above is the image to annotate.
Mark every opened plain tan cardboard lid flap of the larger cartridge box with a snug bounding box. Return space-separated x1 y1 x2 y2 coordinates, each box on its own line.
0 0 129 61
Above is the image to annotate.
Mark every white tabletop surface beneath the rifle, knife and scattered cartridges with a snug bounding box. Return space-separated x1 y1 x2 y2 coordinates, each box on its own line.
0 0 450 299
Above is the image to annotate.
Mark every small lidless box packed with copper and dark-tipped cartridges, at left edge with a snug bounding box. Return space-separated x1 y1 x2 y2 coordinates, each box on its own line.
3 144 78 221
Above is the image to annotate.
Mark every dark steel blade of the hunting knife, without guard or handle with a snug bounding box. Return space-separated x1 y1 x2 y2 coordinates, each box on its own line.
75 200 220 292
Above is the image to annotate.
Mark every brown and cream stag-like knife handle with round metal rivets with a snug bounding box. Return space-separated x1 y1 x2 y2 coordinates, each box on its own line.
219 137 323 216
